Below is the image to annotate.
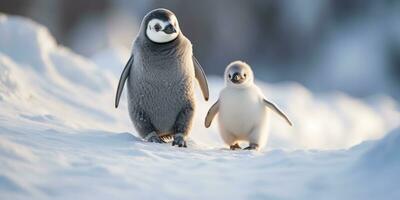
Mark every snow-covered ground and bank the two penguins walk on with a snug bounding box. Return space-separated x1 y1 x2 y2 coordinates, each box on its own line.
0 15 400 199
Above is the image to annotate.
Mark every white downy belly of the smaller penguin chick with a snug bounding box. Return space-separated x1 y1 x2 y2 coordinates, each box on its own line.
218 89 266 139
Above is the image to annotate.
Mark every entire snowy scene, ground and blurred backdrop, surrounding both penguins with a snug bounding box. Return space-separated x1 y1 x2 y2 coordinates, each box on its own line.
0 0 400 200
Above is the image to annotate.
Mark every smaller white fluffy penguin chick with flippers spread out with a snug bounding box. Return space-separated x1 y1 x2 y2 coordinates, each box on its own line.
205 61 292 150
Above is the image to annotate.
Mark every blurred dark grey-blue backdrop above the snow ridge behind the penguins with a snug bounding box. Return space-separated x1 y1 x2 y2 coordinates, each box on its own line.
0 0 400 99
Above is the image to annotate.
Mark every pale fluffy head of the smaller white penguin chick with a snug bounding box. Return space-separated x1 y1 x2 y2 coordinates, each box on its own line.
224 61 254 87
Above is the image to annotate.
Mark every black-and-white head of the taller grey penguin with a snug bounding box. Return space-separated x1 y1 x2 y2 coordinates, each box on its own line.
143 8 180 43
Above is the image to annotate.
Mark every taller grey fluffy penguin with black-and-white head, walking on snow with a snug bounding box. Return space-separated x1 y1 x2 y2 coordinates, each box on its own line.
115 8 209 147
